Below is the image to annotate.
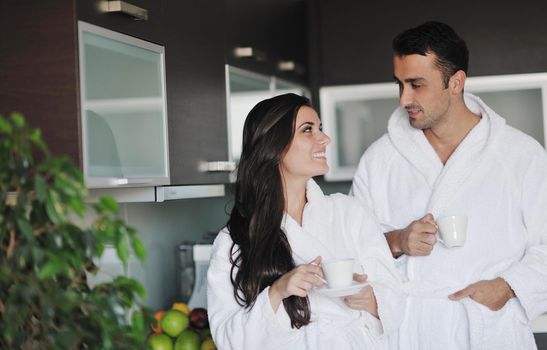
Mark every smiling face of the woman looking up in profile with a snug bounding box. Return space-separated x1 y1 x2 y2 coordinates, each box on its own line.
281 106 330 179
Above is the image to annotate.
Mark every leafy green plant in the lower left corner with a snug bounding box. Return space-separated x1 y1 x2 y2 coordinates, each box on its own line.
0 113 151 350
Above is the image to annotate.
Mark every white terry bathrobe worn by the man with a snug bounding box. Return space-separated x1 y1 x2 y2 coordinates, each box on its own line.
352 94 547 350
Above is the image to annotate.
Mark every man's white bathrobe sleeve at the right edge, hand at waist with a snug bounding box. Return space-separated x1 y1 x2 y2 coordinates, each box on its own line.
501 146 547 321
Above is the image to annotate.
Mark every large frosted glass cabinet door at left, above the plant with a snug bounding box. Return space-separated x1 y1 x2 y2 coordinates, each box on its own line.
78 22 169 188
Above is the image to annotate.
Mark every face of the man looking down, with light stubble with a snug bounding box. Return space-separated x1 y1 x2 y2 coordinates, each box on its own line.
393 53 451 130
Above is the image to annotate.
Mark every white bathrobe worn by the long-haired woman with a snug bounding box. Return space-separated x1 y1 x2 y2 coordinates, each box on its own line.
207 180 404 350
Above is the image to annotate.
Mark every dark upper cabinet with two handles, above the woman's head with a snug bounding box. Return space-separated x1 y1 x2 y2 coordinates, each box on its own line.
224 0 309 85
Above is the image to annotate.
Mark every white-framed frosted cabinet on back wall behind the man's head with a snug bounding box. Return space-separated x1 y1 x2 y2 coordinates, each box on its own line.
320 73 547 181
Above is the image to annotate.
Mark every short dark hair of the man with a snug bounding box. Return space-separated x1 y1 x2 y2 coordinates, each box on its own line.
393 21 469 88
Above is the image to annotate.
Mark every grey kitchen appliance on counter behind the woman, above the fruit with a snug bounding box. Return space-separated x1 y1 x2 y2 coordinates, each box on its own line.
178 242 213 309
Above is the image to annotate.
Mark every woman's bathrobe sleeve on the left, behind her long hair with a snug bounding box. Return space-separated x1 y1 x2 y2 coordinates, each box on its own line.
207 230 301 350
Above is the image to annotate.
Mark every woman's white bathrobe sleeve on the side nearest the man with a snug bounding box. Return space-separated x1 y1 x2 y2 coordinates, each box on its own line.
346 198 406 334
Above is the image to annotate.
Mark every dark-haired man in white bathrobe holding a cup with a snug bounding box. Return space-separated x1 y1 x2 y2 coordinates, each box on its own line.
352 22 547 349
